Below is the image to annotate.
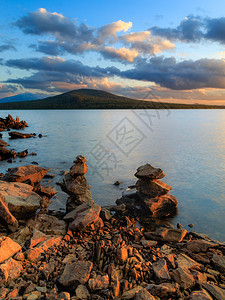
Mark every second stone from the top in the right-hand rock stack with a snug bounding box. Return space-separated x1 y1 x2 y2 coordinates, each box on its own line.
136 179 172 198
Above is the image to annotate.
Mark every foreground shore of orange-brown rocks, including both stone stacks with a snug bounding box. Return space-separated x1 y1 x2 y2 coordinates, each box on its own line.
0 114 225 300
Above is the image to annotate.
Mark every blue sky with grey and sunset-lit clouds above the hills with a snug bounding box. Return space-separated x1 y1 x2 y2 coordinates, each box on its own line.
0 0 225 105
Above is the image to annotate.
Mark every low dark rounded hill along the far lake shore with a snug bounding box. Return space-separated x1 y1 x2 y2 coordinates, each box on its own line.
0 89 225 110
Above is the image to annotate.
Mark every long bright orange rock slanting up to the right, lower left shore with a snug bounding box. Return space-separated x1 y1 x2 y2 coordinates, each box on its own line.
27 236 62 262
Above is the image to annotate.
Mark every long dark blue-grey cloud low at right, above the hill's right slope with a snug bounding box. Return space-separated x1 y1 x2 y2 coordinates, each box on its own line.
120 56 225 90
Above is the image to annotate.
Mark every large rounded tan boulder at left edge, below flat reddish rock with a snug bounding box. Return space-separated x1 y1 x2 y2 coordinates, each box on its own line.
0 180 41 218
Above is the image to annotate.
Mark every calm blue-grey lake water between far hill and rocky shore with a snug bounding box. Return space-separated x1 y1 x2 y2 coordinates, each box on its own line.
0 110 225 242
